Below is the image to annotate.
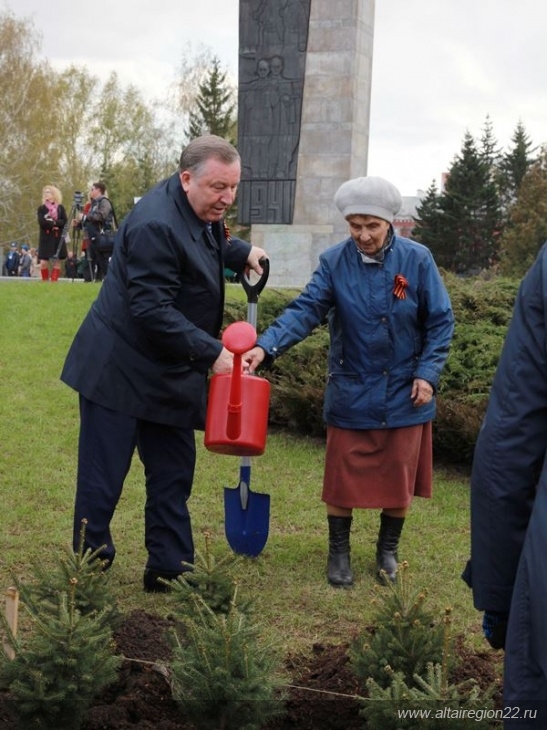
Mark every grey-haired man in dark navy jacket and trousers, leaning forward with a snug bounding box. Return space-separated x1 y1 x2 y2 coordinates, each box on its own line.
61 135 265 591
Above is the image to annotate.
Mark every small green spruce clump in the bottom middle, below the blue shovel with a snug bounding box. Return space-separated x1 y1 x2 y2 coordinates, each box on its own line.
169 536 285 730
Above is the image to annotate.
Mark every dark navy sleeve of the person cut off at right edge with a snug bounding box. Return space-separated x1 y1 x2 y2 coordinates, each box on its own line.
464 247 547 611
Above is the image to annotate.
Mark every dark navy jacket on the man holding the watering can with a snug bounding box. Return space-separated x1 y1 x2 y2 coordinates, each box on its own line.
61 173 251 428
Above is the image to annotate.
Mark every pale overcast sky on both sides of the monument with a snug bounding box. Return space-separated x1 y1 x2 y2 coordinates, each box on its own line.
0 0 547 195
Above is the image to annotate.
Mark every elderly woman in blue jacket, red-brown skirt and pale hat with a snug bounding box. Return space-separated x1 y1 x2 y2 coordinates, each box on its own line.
244 177 454 587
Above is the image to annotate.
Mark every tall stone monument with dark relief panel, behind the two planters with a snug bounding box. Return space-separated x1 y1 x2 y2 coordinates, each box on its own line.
238 0 374 287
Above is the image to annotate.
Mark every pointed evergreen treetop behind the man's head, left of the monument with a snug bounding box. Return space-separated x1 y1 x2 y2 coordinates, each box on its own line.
188 56 236 143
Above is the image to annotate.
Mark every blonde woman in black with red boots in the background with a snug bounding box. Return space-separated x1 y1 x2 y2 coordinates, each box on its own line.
38 185 68 281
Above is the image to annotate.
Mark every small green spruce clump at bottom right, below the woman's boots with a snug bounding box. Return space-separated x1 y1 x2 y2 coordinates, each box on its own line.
356 562 496 730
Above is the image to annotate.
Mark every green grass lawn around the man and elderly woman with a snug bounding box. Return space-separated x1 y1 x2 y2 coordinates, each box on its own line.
0 281 484 652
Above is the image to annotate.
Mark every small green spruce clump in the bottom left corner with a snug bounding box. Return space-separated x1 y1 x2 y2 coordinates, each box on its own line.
0 521 121 730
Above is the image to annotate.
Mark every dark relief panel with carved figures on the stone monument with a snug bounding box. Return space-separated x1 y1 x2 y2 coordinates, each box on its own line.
238 0 310 225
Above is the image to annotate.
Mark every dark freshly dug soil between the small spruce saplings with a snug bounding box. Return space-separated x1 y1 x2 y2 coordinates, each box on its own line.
0 611 501 730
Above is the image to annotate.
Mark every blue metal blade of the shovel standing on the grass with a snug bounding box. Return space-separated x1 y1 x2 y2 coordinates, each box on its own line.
224 487 270 558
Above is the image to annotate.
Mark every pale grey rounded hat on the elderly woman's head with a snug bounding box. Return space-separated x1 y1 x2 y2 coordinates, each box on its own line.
334 177 403 223
